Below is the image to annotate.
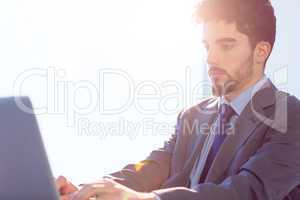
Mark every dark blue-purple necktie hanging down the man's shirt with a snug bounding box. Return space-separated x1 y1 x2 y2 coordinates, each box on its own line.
199 103 235 183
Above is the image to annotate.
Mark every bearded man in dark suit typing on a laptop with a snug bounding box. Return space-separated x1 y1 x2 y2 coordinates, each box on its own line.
57 0 300 200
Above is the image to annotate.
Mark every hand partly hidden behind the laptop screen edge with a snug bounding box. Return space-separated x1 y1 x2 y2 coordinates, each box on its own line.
55 176 78 200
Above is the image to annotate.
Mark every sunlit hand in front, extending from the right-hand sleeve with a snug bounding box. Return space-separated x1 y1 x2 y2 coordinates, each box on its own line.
72 179 155 200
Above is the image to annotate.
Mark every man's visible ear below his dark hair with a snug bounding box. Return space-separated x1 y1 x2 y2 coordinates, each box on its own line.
254 41 271 64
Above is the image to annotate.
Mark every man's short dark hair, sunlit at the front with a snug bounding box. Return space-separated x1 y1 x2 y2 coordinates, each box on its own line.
195 0 276 48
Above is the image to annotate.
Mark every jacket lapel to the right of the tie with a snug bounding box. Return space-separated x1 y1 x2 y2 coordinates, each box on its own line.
205 85 276 182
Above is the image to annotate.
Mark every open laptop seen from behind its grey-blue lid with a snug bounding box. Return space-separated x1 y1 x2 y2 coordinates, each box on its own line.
0 97 59 200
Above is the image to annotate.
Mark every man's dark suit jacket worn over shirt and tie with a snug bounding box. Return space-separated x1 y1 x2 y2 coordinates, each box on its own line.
111 82 300 200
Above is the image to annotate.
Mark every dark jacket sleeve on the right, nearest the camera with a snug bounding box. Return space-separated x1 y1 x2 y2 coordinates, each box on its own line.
154 97 300 200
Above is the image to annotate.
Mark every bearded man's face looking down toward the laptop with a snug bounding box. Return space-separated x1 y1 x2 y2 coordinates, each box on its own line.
203 21 254 96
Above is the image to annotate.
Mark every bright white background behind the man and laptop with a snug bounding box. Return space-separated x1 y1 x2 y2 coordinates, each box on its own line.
0 0 300 183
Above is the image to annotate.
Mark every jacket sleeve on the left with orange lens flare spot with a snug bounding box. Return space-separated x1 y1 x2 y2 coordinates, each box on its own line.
106 112 182 192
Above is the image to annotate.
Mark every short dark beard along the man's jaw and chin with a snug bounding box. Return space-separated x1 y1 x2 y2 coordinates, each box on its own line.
212 54 253 97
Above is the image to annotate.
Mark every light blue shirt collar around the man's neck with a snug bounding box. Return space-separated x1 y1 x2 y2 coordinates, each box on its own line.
219 75 268 115
